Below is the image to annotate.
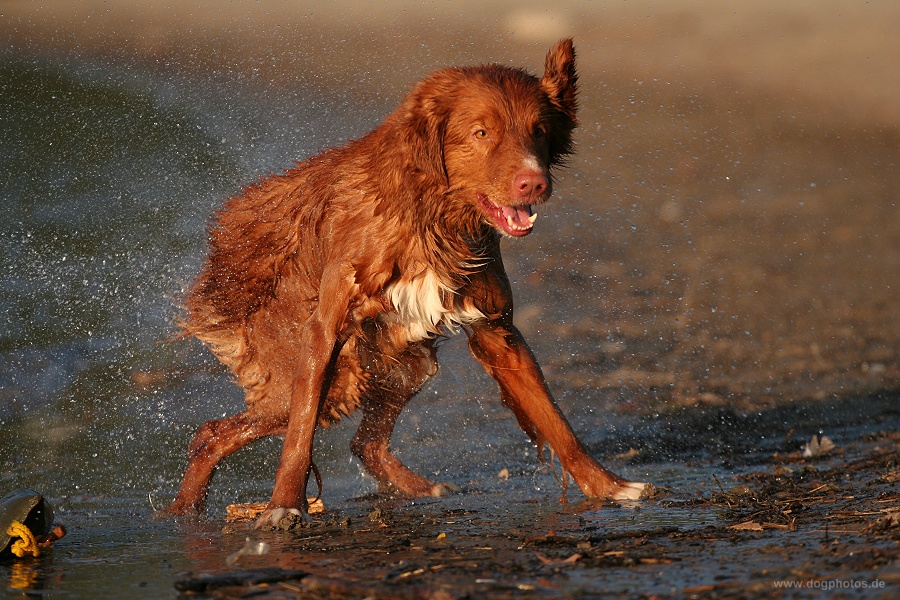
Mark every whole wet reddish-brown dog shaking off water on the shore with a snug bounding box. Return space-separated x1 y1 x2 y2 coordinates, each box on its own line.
167 39 644 525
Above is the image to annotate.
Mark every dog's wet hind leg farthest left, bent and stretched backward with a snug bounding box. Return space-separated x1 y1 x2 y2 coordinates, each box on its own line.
163 412 285 514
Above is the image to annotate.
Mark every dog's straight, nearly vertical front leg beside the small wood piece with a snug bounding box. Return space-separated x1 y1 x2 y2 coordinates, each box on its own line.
256 267 354 528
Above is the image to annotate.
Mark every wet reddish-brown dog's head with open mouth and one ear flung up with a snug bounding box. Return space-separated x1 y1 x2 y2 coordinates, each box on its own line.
397 39 577 237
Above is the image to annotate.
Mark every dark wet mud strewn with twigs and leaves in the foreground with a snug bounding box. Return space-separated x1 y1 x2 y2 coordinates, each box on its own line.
175 414 900 598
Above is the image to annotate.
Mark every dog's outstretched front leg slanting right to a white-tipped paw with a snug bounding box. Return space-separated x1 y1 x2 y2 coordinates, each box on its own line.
469 322 646 500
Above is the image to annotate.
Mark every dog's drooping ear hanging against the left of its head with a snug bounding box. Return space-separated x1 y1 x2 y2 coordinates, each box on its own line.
398 78 449 184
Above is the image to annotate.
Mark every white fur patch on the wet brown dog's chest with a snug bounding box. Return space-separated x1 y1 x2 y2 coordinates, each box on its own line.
385 270 484 342
